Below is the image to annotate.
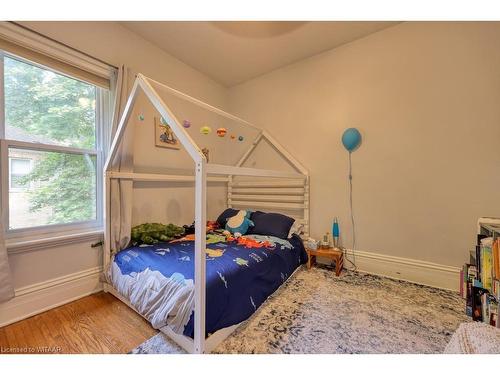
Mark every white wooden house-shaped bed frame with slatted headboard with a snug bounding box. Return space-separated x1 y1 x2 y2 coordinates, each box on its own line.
104 74 309 353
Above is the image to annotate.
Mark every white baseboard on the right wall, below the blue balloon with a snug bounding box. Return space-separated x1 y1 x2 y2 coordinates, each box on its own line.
344 250 460 291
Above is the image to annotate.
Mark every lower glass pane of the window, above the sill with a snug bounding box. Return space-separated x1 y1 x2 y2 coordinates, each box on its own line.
9 147 97 229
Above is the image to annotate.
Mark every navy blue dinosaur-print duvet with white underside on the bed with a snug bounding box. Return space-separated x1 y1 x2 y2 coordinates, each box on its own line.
108 233 307 337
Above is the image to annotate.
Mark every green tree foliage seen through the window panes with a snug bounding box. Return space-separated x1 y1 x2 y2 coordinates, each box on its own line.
4 57 96 223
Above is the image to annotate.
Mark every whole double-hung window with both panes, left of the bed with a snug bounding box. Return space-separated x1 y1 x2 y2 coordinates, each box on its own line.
0 51 109 234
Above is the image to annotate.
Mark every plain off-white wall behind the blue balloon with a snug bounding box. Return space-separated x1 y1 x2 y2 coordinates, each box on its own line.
230 22 500 270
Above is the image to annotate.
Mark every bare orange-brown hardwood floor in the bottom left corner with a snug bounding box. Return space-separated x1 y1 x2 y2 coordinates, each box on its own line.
0 292 157 354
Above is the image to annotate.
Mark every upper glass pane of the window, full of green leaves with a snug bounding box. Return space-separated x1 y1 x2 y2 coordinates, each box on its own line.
4 57 96 149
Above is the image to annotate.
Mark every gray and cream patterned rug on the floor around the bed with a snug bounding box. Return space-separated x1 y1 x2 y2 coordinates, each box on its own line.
132 268 468 354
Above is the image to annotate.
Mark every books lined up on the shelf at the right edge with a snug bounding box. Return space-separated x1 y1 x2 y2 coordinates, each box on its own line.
460 239 500 326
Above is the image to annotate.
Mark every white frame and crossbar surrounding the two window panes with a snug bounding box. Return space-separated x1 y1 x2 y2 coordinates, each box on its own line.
0 50 110 240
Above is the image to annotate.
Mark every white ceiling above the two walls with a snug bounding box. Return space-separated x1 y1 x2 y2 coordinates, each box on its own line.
121 21 397 86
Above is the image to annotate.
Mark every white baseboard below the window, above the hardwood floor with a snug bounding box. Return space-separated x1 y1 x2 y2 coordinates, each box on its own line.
0 267 102 327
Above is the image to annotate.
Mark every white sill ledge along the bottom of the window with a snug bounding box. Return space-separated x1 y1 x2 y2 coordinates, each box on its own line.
6 229 103 254
